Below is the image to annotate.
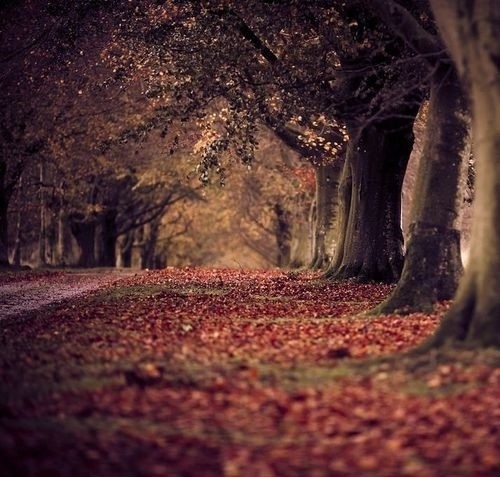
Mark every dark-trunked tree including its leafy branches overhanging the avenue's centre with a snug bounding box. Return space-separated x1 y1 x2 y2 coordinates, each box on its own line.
113 1 421 281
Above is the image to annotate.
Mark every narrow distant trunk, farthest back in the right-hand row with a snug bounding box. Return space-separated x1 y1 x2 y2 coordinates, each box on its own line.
311 160 343 270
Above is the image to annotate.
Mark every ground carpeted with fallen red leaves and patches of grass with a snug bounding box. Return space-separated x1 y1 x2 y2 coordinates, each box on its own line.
0 269 500 477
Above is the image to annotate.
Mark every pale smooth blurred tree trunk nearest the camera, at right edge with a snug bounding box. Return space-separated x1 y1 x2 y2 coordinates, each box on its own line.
424 0 500 349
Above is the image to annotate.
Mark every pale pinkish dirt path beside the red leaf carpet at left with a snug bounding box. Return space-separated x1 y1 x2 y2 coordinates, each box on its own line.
0 270 137 320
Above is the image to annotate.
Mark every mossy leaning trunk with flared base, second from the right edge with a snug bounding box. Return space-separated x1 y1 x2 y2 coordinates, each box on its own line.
373 64 470 314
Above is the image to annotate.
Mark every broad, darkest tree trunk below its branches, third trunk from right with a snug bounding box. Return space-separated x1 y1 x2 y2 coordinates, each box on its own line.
326 117 416 282
